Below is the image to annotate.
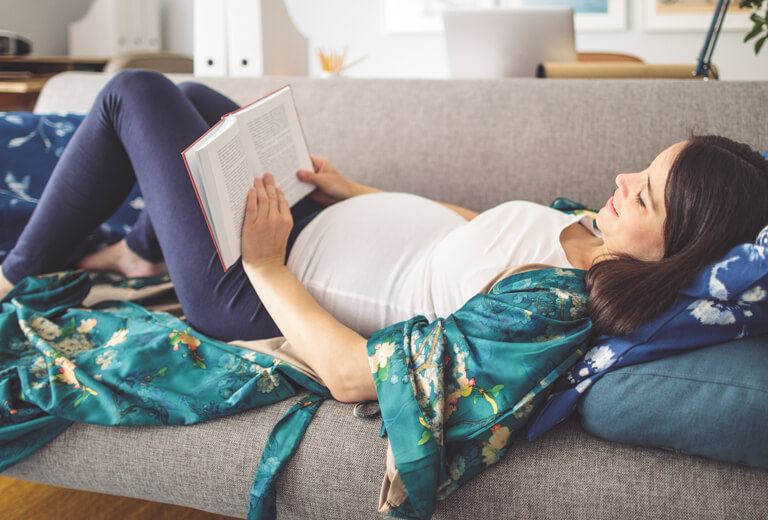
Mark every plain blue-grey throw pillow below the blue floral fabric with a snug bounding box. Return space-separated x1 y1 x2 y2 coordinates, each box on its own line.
579 336 768 469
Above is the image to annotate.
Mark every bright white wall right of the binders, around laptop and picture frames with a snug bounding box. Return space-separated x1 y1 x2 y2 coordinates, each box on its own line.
286 0 768 80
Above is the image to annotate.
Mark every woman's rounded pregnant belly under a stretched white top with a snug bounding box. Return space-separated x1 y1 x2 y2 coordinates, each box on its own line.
287 193 466 336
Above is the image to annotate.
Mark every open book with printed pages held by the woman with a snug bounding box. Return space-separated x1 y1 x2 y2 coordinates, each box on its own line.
182 85 314 271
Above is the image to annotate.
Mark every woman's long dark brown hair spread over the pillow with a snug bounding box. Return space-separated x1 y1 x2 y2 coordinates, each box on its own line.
587 136 768 336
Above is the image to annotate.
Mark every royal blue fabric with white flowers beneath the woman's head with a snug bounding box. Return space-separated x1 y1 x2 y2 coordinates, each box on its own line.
528 223 768 439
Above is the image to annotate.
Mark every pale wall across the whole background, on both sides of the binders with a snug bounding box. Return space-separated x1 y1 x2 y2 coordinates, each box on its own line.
0 0 768 80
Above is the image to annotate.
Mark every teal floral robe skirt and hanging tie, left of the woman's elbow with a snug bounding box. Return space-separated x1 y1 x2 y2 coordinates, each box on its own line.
0 272 330 519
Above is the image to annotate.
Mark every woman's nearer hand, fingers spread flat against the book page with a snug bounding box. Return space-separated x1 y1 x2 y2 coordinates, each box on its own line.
241 173 293 270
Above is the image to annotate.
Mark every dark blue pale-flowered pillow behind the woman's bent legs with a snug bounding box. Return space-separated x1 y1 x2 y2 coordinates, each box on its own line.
0 112 144 263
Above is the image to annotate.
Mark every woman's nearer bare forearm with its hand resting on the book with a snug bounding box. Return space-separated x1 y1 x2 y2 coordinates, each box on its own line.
242 174 376 402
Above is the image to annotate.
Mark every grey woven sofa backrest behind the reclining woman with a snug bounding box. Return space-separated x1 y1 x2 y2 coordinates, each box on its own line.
35 72 768 210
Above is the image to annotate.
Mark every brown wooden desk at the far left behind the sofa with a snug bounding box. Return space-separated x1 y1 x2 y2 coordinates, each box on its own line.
0 56 107 111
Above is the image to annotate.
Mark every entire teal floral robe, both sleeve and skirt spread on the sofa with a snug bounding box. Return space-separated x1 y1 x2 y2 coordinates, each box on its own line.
0 269 591 519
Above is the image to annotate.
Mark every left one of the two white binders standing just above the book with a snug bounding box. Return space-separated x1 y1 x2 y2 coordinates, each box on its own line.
193 0 228 76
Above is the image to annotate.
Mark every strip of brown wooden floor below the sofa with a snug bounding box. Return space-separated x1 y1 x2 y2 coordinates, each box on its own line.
0 477 240 520
